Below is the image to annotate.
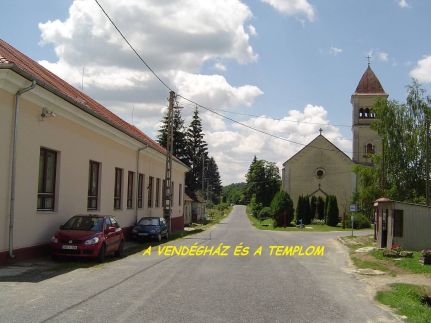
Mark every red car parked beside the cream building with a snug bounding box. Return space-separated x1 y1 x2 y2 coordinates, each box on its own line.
50 215 124 261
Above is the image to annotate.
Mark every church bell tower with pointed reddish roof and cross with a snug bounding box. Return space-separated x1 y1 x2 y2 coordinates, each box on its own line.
351 63 388 165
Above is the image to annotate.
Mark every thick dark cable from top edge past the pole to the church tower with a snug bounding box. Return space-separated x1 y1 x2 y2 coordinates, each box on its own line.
94 0 352 153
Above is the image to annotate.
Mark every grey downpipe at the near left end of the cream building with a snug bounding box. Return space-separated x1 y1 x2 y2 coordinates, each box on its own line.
9 80 36 258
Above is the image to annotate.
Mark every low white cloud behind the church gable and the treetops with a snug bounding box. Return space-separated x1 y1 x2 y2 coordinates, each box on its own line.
204 105 352 185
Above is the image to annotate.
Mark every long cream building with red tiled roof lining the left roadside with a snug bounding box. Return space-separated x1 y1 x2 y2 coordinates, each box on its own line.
0 40 188 261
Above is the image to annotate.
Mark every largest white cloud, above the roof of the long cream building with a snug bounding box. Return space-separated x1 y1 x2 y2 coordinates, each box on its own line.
39 0 262 139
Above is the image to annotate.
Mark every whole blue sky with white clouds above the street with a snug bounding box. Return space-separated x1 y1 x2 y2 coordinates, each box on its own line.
0 0 431 185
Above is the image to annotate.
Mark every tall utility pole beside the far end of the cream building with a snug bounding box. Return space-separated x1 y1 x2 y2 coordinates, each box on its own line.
163 91 176 232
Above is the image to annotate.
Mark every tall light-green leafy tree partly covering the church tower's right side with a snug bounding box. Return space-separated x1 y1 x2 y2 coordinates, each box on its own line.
354 81 431 218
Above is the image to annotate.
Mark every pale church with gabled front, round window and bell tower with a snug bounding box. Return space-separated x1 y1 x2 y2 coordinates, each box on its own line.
282 63 388 214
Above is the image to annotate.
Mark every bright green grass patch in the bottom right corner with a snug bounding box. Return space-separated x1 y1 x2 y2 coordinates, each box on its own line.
376 284 431 323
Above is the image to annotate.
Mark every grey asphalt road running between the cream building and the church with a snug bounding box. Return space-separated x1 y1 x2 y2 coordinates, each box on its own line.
0 206 395 323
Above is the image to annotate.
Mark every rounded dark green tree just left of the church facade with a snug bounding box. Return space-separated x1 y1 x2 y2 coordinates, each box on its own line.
246 157 281 206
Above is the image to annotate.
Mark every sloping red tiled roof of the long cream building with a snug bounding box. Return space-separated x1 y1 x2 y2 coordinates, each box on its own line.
0 39 181 163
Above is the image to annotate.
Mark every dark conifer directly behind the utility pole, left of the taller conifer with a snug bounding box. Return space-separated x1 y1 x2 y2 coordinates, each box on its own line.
157 109 190 165
